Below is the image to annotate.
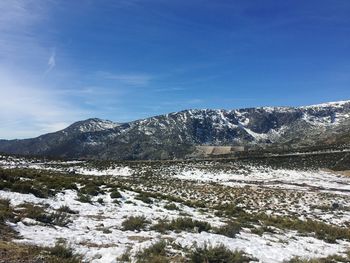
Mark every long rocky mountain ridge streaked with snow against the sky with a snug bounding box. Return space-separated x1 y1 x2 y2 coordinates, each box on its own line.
0 101 350 159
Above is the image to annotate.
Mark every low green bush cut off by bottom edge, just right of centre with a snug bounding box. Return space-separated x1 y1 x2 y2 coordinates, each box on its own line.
188 245 252 263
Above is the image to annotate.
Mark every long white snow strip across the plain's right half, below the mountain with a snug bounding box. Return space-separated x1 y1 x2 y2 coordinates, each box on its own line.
174 166 350 194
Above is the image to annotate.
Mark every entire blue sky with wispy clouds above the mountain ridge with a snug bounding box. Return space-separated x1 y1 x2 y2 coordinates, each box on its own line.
0 0 350 139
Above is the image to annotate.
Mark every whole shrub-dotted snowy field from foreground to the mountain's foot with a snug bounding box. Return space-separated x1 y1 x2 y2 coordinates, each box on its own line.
0 156 350 263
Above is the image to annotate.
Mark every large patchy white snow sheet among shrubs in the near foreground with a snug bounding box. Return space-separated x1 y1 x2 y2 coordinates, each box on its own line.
0 190 350 263
